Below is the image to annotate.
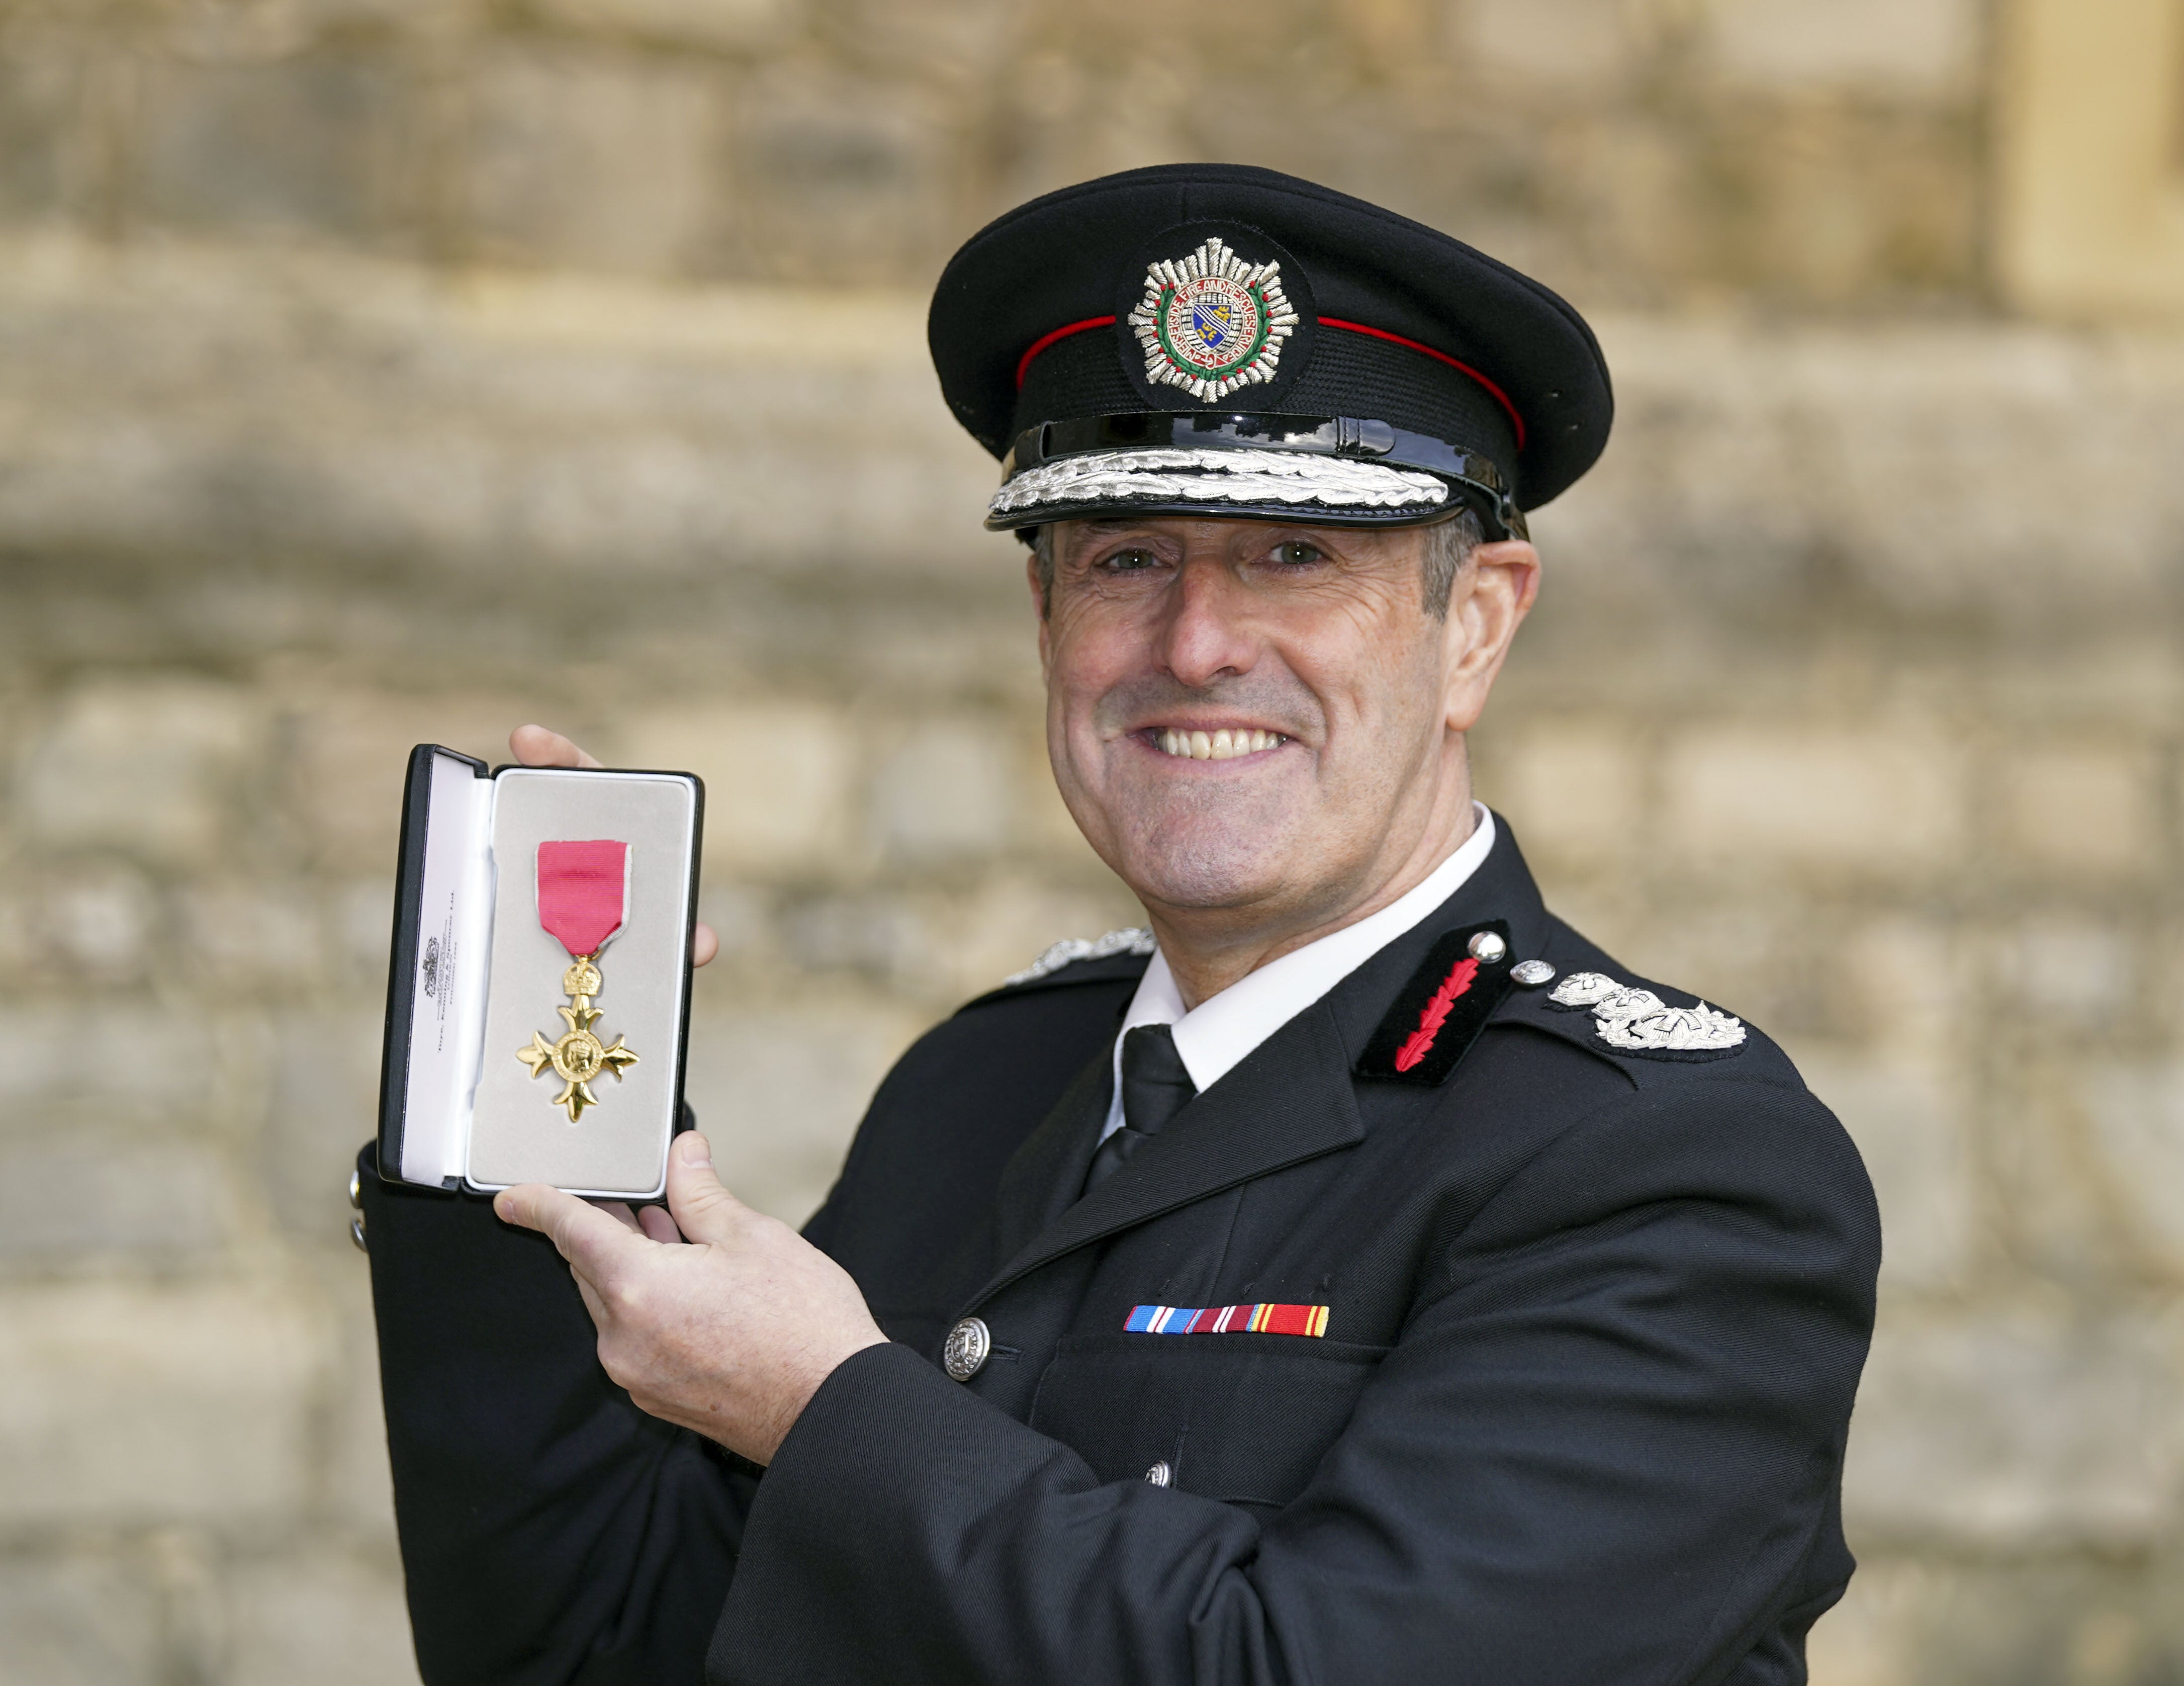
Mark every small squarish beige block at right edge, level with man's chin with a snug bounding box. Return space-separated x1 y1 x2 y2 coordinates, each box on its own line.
1998 745 2160 882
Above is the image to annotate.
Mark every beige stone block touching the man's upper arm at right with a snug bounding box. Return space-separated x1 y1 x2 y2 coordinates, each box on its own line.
1791 1046 1979 1291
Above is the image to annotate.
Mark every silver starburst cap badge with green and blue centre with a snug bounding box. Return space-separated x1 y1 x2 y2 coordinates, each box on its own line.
1129 238 1297 400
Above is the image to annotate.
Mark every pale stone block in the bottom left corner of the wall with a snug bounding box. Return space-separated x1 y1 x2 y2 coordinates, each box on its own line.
0 1553 172 1686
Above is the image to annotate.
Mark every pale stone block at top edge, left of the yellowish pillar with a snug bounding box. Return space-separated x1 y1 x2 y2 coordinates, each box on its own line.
1708 0 1981 98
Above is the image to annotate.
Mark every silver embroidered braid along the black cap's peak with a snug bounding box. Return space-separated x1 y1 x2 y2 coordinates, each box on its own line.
987 450 1448 515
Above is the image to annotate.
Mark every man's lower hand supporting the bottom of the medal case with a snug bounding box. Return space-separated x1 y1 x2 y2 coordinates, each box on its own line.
494 1131 887 1463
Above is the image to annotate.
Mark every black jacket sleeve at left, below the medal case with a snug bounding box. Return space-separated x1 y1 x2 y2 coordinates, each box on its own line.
358 1146 756 1686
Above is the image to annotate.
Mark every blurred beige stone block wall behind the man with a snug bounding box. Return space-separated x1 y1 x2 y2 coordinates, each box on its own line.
0 0 2184 1686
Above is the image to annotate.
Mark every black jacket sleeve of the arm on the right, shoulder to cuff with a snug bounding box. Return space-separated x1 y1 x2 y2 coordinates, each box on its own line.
712 1079 1878 1686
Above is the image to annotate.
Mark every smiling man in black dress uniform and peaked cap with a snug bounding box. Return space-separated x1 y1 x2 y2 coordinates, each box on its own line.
362 166 1880 1686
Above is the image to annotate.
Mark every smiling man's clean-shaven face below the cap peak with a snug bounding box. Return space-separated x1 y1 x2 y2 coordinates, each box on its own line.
1033 517 1535 935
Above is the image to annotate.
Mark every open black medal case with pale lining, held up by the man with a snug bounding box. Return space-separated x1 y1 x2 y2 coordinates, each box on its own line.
380 743 705 1201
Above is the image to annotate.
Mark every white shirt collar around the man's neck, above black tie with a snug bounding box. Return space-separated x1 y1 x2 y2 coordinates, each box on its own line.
1101 802 1494 1140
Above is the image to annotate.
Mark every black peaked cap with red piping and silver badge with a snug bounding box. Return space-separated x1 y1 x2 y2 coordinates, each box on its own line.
928 164 1614 533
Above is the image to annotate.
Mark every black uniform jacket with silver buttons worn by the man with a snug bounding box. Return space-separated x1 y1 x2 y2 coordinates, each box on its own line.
365 830 1880 1686
